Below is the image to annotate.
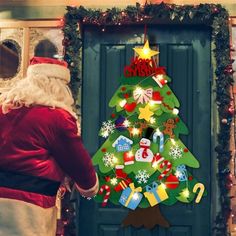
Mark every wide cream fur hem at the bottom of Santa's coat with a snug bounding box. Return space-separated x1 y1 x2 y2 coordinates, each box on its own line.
0 198 57 236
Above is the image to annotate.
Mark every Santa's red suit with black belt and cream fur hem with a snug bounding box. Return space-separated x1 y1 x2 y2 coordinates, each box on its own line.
0 58 98 236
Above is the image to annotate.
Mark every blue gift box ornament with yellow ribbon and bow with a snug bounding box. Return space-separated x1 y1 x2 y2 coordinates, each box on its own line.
119 183 143 210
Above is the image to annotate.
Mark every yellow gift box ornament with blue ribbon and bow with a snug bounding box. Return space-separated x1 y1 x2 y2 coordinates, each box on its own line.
144 182 169 206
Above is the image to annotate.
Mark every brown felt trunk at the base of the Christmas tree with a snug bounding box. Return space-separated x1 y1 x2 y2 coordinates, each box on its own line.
122 205 170 229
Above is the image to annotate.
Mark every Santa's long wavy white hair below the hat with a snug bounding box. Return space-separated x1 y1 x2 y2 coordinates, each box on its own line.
0 74 77 118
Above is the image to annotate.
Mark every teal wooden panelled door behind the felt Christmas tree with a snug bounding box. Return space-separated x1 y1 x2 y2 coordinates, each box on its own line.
78 25 211 236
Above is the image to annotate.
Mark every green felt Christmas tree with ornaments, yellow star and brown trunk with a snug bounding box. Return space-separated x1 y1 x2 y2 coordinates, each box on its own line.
93 41 205 228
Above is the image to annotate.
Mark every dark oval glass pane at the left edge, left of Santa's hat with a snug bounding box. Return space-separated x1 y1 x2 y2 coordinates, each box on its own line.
0 39 21 79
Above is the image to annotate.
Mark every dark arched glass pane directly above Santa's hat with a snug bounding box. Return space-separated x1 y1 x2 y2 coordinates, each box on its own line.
34 39 57 58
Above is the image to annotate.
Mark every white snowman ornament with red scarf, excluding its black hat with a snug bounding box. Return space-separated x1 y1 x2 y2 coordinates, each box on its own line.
135 138 153 162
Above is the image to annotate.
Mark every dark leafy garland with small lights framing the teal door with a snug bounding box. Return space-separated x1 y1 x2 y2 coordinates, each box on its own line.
63 3 233 236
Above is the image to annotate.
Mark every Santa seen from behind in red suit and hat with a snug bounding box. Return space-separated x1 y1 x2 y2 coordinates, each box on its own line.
0 57 98 236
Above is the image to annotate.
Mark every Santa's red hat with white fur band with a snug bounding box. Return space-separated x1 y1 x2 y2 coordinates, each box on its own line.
27 57 70 83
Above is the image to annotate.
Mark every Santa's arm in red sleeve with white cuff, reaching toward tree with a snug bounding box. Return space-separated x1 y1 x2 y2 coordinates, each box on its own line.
52 110 98 197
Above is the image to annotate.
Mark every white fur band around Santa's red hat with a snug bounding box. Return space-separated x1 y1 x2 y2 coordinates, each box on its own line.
27 63 70 83
